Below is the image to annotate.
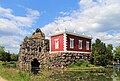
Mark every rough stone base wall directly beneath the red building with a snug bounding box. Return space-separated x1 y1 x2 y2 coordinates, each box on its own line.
49 53 90 67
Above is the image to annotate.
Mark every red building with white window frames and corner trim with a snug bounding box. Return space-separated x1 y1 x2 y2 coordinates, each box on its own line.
50 31 92 54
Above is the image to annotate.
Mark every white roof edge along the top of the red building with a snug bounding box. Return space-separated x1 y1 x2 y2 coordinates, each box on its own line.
50 31 92 39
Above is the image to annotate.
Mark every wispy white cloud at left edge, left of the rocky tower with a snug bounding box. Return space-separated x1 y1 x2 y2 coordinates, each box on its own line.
0 7 40 53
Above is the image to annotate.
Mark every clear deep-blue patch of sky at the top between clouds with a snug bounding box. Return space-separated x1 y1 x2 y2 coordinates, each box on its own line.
0 0 79 27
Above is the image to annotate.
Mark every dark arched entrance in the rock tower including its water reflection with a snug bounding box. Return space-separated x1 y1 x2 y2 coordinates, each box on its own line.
31 59 40 74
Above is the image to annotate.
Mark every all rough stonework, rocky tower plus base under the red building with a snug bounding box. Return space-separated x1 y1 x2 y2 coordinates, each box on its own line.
19 29 90 71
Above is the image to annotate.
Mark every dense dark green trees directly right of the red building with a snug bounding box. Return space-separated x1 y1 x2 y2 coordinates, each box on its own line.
92 39 113 66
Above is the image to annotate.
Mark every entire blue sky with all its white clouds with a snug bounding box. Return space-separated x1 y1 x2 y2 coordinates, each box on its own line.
0 0 120 53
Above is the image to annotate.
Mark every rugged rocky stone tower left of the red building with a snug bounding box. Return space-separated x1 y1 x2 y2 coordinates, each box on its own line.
19 29 49 70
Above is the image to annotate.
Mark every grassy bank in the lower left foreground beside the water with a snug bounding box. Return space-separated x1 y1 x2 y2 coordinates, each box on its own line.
0 61 55 81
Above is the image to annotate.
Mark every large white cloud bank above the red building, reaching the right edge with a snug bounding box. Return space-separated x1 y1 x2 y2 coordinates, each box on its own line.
42 0 120 46
